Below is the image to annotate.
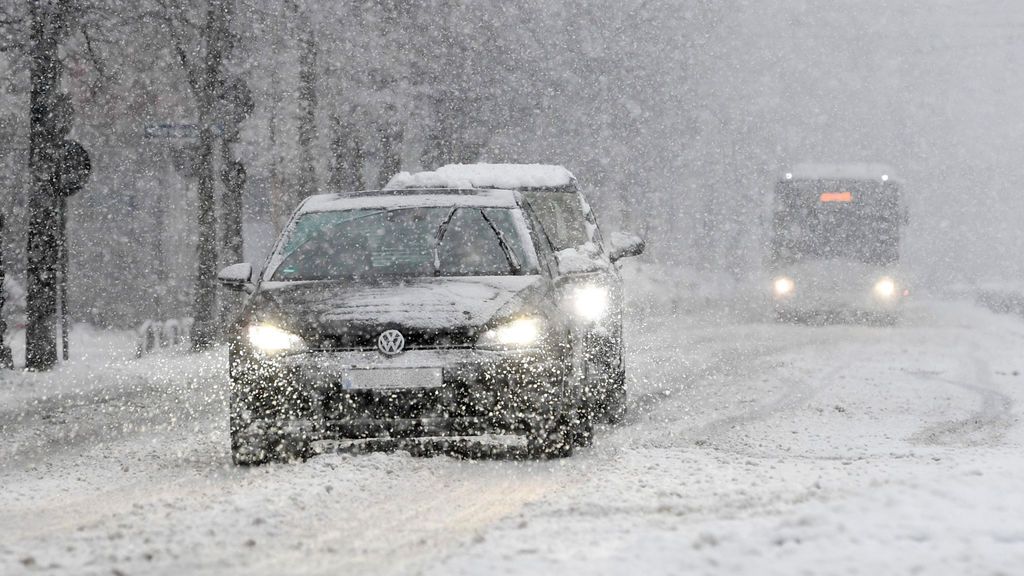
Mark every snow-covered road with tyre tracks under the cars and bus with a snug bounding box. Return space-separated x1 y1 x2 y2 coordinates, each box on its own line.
0 301 1024 575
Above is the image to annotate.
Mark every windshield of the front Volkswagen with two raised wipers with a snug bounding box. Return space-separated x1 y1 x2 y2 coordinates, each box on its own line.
269 206 537 281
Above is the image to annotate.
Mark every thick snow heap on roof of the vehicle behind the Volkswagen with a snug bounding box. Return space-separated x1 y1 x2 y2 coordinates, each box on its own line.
384 164 575 190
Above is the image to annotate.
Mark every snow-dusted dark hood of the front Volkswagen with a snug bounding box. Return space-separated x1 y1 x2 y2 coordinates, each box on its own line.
253 276 542 335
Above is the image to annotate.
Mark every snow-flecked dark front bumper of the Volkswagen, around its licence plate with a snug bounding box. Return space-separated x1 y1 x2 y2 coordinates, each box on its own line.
231 348 574 441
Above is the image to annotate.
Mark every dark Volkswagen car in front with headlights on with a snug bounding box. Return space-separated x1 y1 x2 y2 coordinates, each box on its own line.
219 190 591 463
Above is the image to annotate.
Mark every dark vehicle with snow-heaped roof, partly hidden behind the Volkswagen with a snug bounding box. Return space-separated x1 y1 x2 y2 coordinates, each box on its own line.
387 164 645 422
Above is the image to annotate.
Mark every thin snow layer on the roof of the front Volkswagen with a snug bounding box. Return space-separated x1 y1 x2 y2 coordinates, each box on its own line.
299 189 517 213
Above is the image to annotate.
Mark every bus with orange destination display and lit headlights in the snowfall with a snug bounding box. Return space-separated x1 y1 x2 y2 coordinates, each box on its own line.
767 164 909 321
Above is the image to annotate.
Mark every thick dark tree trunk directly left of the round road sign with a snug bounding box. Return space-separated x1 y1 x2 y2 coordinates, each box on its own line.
26 2 67 370
